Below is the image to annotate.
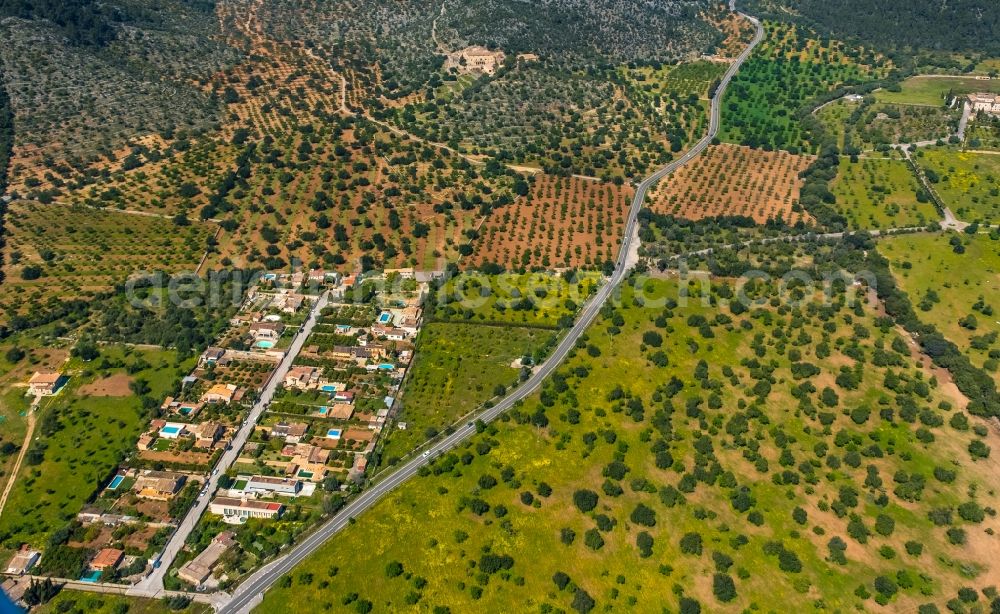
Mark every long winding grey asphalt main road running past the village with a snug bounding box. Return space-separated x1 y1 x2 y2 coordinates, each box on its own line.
219 10 764 613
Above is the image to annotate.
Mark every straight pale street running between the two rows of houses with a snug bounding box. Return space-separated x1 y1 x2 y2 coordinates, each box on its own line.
128 294 329 597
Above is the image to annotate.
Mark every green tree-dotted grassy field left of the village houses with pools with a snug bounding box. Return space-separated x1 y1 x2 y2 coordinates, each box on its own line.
0 346 193 548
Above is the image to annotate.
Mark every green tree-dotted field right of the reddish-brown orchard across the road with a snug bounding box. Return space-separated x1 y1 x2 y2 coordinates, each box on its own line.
832 158 937 229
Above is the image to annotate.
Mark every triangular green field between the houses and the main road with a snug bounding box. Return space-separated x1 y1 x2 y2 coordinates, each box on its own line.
382 322 556 463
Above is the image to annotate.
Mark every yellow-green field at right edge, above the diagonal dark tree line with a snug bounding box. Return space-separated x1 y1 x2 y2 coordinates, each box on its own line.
879 234 1000 381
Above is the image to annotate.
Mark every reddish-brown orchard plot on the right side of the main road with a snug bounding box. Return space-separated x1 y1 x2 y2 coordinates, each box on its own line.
649 144 813 224
